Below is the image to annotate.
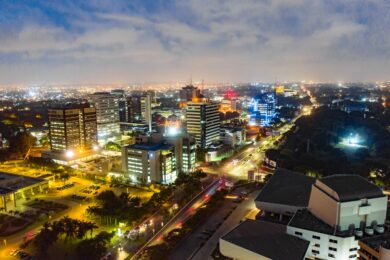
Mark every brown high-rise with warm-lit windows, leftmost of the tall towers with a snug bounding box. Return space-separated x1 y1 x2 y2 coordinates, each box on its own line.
48 105 97 152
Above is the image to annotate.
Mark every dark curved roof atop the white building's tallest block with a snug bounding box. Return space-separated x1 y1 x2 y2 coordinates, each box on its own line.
319 174 384 202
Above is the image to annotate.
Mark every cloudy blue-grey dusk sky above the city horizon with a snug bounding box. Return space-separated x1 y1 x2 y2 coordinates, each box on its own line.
0 0 390 84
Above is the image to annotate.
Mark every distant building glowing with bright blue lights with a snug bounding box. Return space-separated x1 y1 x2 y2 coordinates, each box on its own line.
250 92 276 126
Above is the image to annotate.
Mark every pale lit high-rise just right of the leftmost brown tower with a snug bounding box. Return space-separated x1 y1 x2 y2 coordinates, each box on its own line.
89 92 120 144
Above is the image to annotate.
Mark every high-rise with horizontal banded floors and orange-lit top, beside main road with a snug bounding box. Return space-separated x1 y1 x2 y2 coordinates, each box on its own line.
186 100 220 148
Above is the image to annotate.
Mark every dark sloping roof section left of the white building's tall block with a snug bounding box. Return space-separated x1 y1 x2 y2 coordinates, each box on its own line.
255 168 315 207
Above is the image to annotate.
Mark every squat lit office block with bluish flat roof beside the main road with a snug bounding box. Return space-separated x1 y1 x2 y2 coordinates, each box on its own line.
122 142 177 184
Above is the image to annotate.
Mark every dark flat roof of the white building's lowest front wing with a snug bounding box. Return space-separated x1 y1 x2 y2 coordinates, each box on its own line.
221 219 309 260
